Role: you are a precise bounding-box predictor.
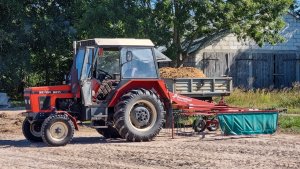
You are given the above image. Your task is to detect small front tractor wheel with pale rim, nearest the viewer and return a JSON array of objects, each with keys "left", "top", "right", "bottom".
[{"left": 41, "top": 114, "right": 75, "bottom": 146}]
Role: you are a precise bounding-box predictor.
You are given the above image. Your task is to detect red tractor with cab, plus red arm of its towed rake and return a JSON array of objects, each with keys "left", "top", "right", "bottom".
[{"left": 22, "top": 38, "right": 278, "bottom": 146}]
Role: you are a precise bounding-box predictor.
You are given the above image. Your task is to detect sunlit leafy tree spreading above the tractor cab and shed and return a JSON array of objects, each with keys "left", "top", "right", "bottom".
[{"left": 80, "top": 0, "right": 292, "bottom": 66}]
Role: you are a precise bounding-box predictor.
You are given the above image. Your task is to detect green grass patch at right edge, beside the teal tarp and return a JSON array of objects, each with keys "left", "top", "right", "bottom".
[{"left": 278, "top": 115, "right": 300, "bottom": 134}]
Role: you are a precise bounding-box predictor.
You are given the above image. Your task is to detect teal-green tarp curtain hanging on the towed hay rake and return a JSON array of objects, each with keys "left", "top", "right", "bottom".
[{"left": 217, "top": 112, "right": 278, "bottom": 135}]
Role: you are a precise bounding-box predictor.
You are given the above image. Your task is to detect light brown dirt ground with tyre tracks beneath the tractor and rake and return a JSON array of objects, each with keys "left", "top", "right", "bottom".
[{"left": 0, "top": 111, "right": 300, "bottom": 169}]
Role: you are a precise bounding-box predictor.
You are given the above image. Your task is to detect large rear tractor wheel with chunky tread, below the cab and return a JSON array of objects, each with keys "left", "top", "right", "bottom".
[{"left": 114, "top": 89, "right": 163, "bottom": 141}]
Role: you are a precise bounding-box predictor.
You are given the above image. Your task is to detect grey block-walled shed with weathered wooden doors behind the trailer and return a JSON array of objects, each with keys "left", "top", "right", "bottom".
[{"left": 189, "top": 14, "right": 300, "bottom": 88}]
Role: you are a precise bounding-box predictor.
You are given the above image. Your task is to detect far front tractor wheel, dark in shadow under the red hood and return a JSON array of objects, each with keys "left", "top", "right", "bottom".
[{"left": 22, "top": 118, "right": 43, "bottom": 142}]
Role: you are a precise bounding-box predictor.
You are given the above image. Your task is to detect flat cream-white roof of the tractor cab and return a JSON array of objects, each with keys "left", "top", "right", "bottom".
[{"left": 76, "top": 38, "right": 154, "bottom": 47}]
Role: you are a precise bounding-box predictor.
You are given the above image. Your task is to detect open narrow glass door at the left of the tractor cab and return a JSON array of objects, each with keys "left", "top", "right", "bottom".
[{"left": 80, "top": 47, "right": 95, "bottom": 106}]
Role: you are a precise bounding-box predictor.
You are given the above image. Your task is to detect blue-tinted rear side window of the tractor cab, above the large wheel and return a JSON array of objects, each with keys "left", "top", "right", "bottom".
[{"left": 121, "top": 48, "right": 158, "bottom": 78}]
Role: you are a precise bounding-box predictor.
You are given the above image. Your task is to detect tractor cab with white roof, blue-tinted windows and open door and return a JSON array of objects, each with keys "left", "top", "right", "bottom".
[{"left": 71, "top": 39, "right": 159, "bottom": 106}]
